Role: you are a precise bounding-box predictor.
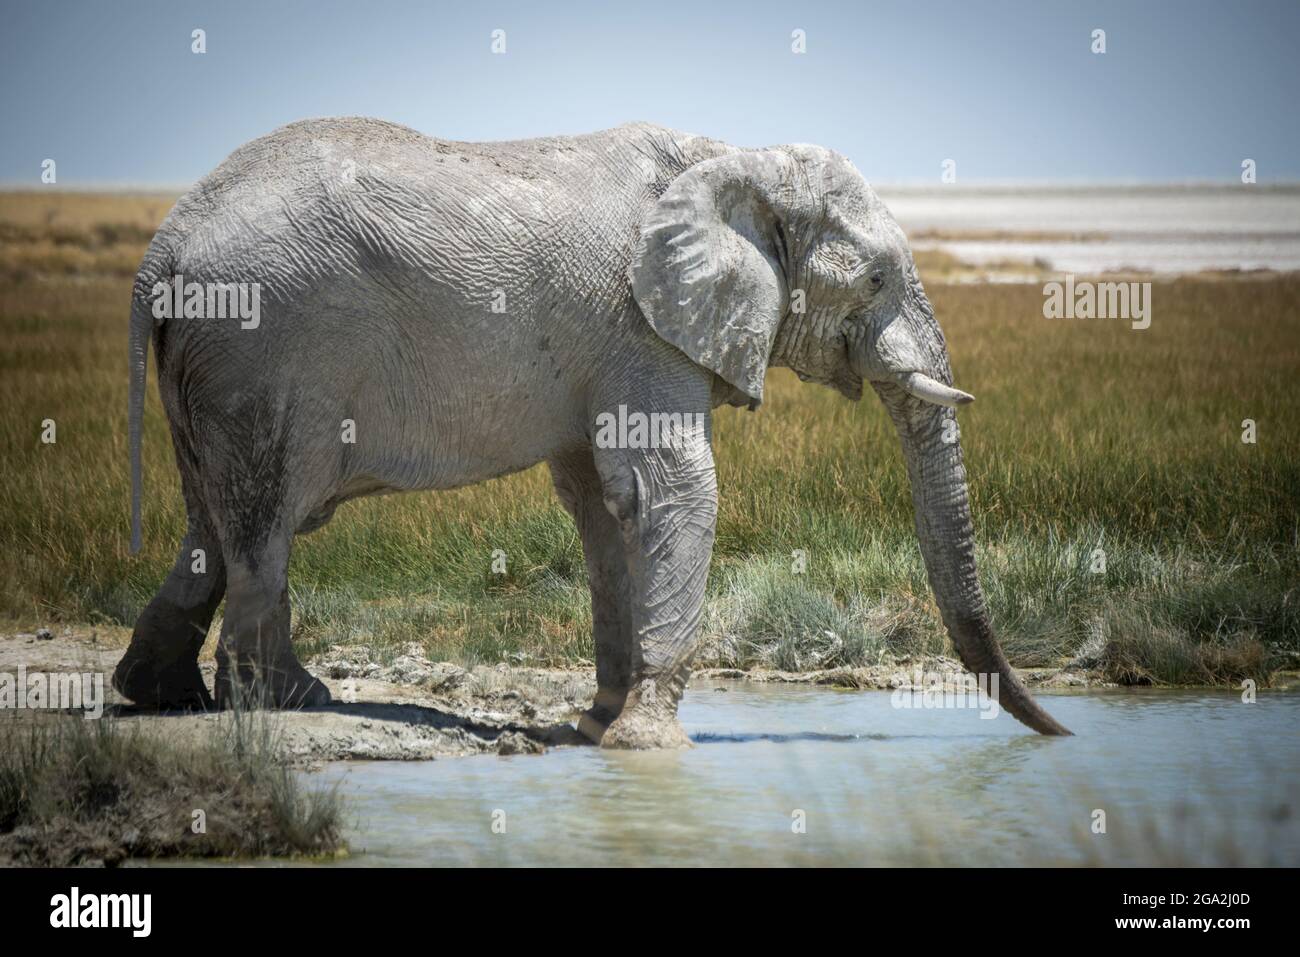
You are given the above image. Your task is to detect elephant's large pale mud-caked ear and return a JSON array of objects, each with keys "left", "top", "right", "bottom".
[{"left": 628, "top": 151, "right": 793, "bottom": 404}]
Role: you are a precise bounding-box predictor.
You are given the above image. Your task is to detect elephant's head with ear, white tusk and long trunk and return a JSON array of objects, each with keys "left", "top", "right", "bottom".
[{"left": 628, "top": 146, "right": 1069, "bottom": 735}]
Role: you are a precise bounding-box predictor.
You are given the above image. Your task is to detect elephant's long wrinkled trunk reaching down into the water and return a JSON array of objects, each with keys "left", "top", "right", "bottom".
[{"left": 878, "top": 400, "right": 1070, "bottom": 735}]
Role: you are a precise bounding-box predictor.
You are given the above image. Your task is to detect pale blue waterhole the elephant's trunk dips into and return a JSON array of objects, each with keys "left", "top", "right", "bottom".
[{"left": 308, "top": 683, "right": 1300, "bottom": 866}]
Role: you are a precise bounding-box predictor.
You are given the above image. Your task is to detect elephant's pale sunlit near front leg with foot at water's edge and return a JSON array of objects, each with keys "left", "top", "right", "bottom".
[{"left": 595, "top": 412, "right": 718, "bottom": 748}]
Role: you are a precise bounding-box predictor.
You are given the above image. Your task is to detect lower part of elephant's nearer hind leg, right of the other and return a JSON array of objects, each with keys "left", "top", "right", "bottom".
[{"left": 216, "top": 531, "right": 330, "bottom": 707}]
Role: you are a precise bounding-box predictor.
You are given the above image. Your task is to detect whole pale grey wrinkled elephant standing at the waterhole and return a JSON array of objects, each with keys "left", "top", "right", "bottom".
[{"left": 114, "top": 118, "right": 1066, "bottom": 748}]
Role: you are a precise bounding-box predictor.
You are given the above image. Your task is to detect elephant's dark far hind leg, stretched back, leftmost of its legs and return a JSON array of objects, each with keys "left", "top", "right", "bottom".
[{"left": 113, "top": 495, "right": 226, "bottom": 709}]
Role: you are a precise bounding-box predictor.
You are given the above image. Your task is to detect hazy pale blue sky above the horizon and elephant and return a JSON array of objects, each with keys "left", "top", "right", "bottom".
[{"left": 0, "top": 0, "right": 1300, "bottom": 186}]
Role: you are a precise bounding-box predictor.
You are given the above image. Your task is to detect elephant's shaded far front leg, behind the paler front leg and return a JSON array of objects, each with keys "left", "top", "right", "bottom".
[{"left": 550, "top": 449, "right": 633, "bottom": 744}]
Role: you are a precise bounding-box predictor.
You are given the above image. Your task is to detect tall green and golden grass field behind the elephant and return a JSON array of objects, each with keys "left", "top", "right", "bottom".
[{"left": 0, "top": 195, "right": 1300, "bottom": 684}]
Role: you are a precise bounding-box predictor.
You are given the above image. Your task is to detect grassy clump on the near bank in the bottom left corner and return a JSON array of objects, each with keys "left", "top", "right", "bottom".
[{"left": 0, "top": 710, "right": 345, "bottom": 867}]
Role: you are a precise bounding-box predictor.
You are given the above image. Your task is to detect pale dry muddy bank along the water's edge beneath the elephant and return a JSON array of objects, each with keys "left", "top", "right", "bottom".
[{"left": 0, "top": 629, "right": 1295, "bottom": 766}]
